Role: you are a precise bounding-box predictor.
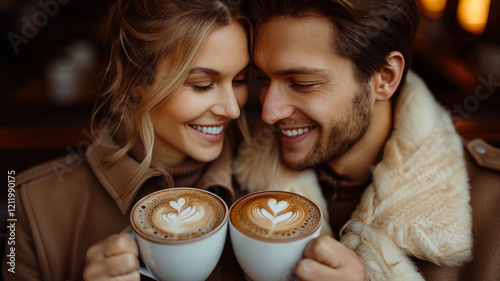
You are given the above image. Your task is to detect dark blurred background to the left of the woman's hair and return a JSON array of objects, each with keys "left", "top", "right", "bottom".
[{"left": 0, "top": 0, "right": 113, "bottom": 172}]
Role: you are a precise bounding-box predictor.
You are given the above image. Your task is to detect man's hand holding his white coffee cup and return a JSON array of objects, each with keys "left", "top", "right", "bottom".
[{"left": 296, "top": 235, "right": 366, "bottom": 281}]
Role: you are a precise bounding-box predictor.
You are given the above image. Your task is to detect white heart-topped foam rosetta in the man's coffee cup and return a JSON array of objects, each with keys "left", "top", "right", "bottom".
[{"left": 250, "top": 198, "right": 305, "bottom": 236}]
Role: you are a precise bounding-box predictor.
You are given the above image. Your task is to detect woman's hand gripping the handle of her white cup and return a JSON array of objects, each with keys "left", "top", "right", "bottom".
[{"left": 83, "top": 234, "right": 141, "bottom": 281}]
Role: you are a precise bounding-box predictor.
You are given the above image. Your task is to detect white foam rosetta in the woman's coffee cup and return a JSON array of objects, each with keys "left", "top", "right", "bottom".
[{"left": 153, "top": 197, "right": 205, "bottom": 235}]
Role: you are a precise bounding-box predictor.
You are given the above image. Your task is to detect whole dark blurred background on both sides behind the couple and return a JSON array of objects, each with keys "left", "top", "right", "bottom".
[{"left": 0, "top": 0, "right": 500, "bottom": 270}]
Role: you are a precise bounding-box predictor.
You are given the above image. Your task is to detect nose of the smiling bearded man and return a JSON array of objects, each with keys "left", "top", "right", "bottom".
[{"left": 261, "top": 83, "right": 293, "bottom": 124}]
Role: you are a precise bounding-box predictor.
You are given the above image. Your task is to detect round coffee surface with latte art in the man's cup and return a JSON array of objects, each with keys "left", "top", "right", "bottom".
[{"left": 230, "top": 191, "right": 321, "bottom": 240}]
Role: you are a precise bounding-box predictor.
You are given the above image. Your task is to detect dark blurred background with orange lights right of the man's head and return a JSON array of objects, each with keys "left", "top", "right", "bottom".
[{"left": 413, "top": 0, "right": 500, "bottom": 147}]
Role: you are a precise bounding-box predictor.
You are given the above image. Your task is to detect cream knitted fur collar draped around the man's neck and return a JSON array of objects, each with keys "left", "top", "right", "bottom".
[{"left": 235, "top": 72, "right": 472, "bottom": 280}]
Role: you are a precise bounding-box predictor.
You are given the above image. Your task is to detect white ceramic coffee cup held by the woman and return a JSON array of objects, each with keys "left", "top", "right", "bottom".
[{"left": 131, "top": 188, "right": 229, "bottom": 281}]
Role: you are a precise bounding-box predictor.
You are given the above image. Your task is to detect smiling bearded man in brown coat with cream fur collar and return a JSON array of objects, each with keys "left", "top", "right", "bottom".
[{"left": 236, "top": 0, "right": 500, "bottom": 280}]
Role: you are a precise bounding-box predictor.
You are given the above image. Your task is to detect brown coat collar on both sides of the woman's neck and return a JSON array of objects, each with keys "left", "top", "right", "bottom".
[{"left": 86, "top": 133, "right": 234, "bottom": 214}]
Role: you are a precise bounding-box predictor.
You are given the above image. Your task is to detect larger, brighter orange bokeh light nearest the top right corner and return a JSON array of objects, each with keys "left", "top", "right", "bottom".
[{"left": 457, "top": 0, "right": 491, "bottom": 35}]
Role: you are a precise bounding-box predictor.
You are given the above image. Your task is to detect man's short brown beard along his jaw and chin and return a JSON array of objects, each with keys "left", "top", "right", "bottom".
[{"left": 280, "top": 83, "right": 373, "bottom": 170}]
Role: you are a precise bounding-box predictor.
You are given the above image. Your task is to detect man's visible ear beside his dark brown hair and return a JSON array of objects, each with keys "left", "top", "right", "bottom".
[{"left": 373, "top": 51, "right": 405, "bottom": 101}]
